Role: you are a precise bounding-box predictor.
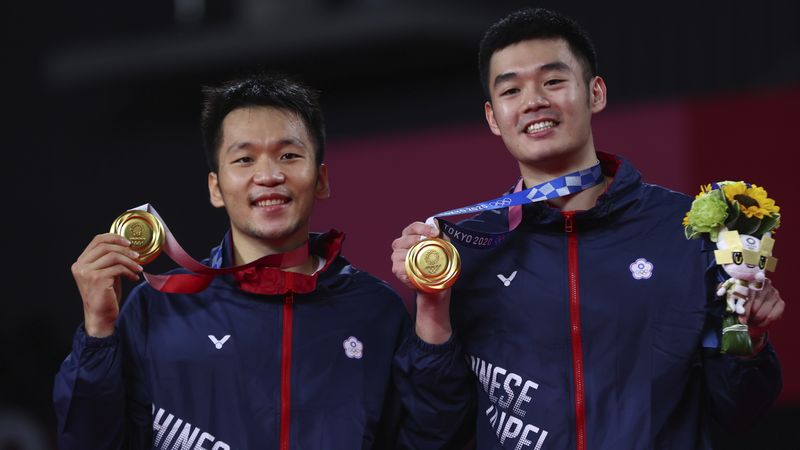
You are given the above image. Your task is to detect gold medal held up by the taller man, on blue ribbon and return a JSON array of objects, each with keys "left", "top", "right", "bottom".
[{"left": 405, "top": 238, "right": 461, "bottom": 293}]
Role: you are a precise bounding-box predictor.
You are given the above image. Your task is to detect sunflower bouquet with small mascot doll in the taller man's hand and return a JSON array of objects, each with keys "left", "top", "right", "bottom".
[{"left": 683, "top": 181, "right": 781, "bottom": 355}]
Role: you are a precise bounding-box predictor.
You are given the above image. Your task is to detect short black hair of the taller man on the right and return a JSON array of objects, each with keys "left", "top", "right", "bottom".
[{"left": 478, "top": 8, "right": 597, "bottom": 100}]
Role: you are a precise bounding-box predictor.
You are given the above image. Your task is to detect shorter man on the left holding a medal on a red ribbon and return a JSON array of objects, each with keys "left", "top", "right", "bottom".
[{"left": 54, "top": 72, "right": 469, "bottom": 450}]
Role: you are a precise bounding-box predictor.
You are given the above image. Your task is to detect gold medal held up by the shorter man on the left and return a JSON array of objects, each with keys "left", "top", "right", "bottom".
[{"left": 111, "top": 210, "right": 165, "bottom": 264}]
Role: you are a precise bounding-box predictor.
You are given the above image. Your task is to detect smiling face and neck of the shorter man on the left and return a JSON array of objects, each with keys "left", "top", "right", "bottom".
[{"left": 207, "top": 106, "right": 330, "bottom": 266}]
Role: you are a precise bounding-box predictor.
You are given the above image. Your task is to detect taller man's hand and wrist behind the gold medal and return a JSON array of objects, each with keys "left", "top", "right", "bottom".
[{"left": 392, "top": 222, "right": 453, "bottom": 344}]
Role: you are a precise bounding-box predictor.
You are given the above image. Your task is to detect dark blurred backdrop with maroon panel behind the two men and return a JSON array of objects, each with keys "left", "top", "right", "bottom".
[{"left": 0, "top": 0, "right": 800, "bottom": 450}]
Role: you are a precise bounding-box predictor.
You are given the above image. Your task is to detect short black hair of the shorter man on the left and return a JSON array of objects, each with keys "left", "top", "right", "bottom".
[{"left": 200, "top": 72, "right": 325, "bottom": 172}]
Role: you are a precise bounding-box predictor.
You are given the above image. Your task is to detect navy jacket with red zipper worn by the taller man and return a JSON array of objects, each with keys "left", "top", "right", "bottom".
[{"left": 451, "top": 154, "right": 781, "bottom": 450}]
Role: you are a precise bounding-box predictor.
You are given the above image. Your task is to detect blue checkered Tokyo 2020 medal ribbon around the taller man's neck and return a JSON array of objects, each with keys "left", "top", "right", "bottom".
[{"left": 428, "top": 162, "right": 603, "bottom": 249}]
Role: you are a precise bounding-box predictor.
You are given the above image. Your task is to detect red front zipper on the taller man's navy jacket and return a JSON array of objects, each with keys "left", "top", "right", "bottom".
[{"left": 563, "top": 211, "right": 586, "bottom": 450}]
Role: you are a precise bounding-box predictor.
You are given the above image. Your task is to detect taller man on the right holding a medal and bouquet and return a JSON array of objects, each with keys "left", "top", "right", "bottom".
[{"left": 391, "top": 9, "right": 784, "bottom": 450}]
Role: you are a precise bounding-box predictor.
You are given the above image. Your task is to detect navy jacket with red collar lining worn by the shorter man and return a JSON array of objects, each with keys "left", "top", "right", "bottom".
[{"left": 54, "top": 232, "right": 471, "bottom": 450}]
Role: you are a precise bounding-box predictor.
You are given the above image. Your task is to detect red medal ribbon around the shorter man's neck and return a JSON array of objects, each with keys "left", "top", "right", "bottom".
[{"left": 112, "top": 203, "right": 308, "bottom": 294}]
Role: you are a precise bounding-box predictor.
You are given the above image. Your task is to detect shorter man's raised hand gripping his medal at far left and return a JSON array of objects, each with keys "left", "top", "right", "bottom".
[{"left": 72, "top": 233, "right": 142, "bottom": 337}]
